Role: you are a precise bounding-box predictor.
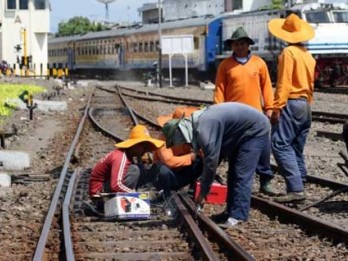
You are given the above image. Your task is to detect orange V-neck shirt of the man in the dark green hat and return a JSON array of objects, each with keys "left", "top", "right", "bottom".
[{"left": 214, "top": 55, "right": 274, "bottom": 111}]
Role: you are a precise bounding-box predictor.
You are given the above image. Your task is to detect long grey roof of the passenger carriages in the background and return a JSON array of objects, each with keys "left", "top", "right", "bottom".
[{"left": 48, "top": 16, "right": 214, "bottom": 44}]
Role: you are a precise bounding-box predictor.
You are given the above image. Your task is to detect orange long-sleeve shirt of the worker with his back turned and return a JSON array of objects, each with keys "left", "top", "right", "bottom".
[{"left": 274, "top": 45, "right": 316, "bottom": 111}]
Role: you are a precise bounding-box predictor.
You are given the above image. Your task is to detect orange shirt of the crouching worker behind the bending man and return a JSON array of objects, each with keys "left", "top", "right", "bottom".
[{"left": 154, "top": 134, "right": 192, "bottom": 169}]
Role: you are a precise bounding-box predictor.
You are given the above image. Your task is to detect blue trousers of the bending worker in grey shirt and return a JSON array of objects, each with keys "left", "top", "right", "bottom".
[{"left": 226, "top": 133, "right": 270, "bottom": 220}]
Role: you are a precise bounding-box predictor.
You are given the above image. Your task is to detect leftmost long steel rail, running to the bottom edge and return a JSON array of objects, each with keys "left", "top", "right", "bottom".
[{"left": 33, "top": 93, "right": 93, "bottom": 261}]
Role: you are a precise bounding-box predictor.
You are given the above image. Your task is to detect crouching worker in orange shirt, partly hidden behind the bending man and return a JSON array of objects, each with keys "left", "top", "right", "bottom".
[{"left": 154, "top": 107, "right": 203, "bottom": 199}]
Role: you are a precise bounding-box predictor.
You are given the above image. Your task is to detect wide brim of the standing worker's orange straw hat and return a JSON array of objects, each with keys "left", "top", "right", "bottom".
[{"left": 268, "top": 18, "right": 314, "bottom": 43}]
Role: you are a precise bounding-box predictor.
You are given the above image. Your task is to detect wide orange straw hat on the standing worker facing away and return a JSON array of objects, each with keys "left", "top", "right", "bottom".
[{"left": 268, "top": 14, "right": 314, "bottom": 43}]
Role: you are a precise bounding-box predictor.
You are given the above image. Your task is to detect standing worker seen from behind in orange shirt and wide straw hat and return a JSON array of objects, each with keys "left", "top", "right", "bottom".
[{"left": 268, "top": 14, "right": 316, "bottom": 202}]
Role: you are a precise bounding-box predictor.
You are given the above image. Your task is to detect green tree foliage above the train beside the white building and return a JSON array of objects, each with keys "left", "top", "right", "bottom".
[{"left": 56, "top": 16, "right": 109, "bottom": 36}]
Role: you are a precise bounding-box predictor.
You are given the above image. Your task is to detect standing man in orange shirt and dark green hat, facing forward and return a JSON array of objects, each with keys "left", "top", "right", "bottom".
[{"left": 214, "top": 27, "right": 276, "bottom": 196}]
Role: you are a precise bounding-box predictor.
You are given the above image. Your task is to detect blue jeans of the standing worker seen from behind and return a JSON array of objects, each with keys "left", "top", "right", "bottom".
[{"left": 271, "top": 98, "right": 312, "bottom": 192}]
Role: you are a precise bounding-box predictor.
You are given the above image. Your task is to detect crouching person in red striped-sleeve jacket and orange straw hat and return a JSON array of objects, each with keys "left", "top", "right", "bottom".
[{"left": 89, "top": 125, "right": 164, "bottom": 198}]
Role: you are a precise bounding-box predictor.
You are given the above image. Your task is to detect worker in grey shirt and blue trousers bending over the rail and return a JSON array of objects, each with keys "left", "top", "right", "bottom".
[{"left": 162, "top": 102, "right": 270, "bottom": 227}]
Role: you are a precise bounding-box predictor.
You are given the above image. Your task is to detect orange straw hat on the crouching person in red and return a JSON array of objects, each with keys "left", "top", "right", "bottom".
[{"left": 115, "top": 125, "right": 164, "bottom": 150}]
